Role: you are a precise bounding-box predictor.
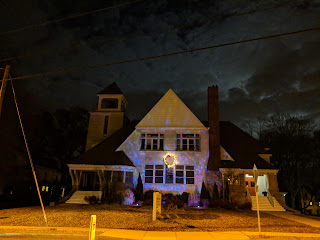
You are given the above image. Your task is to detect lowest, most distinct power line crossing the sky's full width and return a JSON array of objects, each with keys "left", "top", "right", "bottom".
[{"left": 0, "top": 27, "right": 320, "bottom": 82}]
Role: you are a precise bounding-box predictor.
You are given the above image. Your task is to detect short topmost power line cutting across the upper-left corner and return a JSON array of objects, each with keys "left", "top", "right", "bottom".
[{"left": 0, "top": 0, "right": 143, "bottom": 37}]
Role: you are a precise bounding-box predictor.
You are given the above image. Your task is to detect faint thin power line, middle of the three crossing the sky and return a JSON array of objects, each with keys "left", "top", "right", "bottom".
[{"left": 0, "top": 0, "right": 312, "bottom": 62}]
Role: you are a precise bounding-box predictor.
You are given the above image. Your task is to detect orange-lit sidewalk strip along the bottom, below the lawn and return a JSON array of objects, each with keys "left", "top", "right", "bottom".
[{"left": 0, "top": 226, "right": 320, "bottom": 240}]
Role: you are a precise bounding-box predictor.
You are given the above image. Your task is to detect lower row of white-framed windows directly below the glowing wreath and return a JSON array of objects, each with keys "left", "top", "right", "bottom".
[{"left": 144, "top": 165, "right": 194, "bottom": 184}]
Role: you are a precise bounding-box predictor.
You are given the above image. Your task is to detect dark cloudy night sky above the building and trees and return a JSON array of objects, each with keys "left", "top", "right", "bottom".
[{"left": 0, "top": 0, "right": 320, "bottom": 125}]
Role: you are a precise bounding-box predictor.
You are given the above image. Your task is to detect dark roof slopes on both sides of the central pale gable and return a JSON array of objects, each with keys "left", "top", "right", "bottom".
[{"left": 72, "top": 118, "right": 275, "bottom": 169}]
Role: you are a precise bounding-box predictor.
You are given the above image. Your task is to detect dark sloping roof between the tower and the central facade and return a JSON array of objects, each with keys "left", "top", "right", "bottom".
[{"left": 71, "top": 124, "right": 134, "bottom": 166}]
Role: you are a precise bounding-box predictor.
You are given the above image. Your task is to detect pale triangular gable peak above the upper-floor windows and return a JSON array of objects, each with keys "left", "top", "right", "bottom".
[{"left": 136, "top": 89, "right": 205, "bottom": 128}]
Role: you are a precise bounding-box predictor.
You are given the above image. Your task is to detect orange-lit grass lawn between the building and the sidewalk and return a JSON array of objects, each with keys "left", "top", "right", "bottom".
[{"left": 0, "top": 204, "right": 320, "bottom": 233}]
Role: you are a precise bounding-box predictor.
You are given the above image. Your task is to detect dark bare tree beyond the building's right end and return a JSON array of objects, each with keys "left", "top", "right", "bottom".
[{"left": 260, "top": 114, "right": 314, "bottom": 208}]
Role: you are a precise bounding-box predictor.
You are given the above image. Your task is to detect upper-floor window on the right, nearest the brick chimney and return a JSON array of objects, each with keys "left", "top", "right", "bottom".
[{"left": 177, "top": 133, "right": 200, "bottom": 151}]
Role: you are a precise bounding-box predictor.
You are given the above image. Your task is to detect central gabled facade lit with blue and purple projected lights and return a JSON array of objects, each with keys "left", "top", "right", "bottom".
[{"left": 117, "top": 89, "right": 209, "bottom": 194}]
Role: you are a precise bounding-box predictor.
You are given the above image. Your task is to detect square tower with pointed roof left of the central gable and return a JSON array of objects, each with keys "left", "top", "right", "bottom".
[{"left": 86, "top": 82, "right": 127, "bottom": 151}]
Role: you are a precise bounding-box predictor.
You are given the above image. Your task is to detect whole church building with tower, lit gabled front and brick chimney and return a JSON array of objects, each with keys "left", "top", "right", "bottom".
[{"left": 68, "top": 83, "right": 283, "bottom": 210}]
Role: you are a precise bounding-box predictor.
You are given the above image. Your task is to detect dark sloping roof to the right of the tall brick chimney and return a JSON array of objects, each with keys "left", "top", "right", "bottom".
[{"left": 220, "top": 121, "right": 275, "bottom": 169}]
